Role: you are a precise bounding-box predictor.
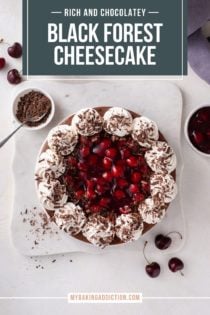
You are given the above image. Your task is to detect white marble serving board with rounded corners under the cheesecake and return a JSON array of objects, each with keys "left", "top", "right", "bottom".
[{"left": 11, "top": 81, "right": 185, "bottom": 256}]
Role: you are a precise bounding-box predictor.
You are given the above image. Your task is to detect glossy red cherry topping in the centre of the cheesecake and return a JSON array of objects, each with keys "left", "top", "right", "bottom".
[{"left": 60, "top": 130, "right": 152, "bottom": 216}]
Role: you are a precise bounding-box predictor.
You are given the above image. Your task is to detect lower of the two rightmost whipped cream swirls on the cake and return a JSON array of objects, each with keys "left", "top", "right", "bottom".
[{"left": 150, "top": 173, "right": 177, "bottom": 203}]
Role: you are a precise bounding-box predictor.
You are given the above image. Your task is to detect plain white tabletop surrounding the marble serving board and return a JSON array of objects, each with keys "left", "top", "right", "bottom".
[{"left": 0, "top": 0, "right": 210, "bottom": 315}]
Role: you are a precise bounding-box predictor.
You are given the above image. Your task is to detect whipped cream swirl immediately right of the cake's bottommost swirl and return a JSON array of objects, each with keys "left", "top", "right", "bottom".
[{"left": 115, "top": 213, "right": 144, "bottom": 243}]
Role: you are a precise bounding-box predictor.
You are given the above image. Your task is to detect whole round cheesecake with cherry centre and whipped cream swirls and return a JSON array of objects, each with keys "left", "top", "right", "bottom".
[{"left": 35, "top": 107, "right": 177, "bottom": 248}]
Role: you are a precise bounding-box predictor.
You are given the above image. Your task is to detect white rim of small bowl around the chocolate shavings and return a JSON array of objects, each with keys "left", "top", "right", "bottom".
[{"left": 12, "top": 88, "right": 55, "bottom": 130}]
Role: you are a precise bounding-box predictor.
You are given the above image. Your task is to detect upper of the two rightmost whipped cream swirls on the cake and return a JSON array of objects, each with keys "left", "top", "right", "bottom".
[{"left": 145, "top": 141, "right": 177, "bottom": 173}]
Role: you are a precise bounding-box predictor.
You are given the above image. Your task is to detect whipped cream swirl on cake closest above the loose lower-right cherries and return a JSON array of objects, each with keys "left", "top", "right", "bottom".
[{"left": 138, "top": 197, "right": 166, "bottom": 224}]
